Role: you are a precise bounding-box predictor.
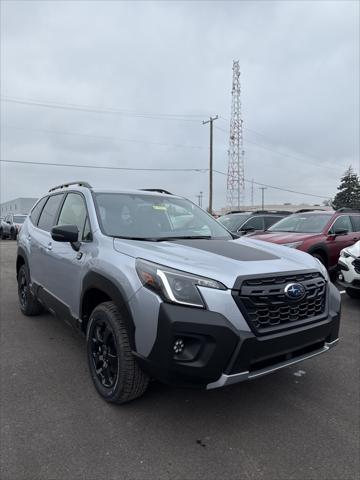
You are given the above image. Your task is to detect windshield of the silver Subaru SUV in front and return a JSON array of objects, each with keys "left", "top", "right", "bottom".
[{"left": 95, "top": 193, "right": 231, "bottom": 241}]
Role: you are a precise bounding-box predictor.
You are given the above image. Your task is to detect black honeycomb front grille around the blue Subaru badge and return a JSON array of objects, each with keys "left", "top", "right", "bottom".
[{"left": 233, "top": 272, "right": 326, "bottom": 335}]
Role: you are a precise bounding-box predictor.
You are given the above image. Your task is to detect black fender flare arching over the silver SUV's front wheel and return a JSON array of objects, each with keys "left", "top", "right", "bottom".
[{"left": 79, "top": 271, "right": 136, "bottom": 350}]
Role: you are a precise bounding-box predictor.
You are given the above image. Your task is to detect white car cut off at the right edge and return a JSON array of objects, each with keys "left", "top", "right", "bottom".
[{"left": 338, "top": 241, "right": 360, "bottom": 298}]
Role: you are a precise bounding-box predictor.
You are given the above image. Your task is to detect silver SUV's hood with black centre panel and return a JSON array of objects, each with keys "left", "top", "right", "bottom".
[{"left": 114, "top": 237, "right": 319, "bottom": 288}]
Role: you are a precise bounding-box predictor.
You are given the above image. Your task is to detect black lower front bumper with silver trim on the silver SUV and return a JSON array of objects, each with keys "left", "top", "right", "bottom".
[{"left": 134, "top": 303, "right": 340, "bottom": 389}]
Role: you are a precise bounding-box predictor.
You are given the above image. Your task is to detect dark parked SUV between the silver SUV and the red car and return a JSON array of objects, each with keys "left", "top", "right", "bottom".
[{"left": 218, "top": 210, "right": 291, "bottom": 235}]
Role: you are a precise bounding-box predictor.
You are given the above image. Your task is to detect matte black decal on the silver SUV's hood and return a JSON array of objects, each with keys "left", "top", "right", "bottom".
[{"left": 172, "top": 240, "right": 279, "bottom": 262}]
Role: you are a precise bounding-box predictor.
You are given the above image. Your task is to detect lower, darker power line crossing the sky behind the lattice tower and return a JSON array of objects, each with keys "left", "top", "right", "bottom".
[{"left": 0, "top": 159, "right": 331, "bottom": 200}]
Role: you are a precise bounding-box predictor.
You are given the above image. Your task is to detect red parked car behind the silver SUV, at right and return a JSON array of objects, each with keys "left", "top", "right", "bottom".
[{"left": 249, "top": 208, "right": 360, "bottom": 272}]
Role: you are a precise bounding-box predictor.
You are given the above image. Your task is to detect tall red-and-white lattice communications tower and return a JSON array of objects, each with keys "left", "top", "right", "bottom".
[{"left": 226, "top": 60, "right": 245, "bottom": 209}]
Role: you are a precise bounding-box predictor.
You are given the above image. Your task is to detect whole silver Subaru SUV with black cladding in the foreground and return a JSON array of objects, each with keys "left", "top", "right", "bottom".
[{"left": 16, "top": 182, "right": 340, "bottom": 403}]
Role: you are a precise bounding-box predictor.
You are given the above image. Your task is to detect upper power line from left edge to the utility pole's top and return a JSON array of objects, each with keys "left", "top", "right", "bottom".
[{"left": 0, "top": 96, "right": 204, "bottom": 123}]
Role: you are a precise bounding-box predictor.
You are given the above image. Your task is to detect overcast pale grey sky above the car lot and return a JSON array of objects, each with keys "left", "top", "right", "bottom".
[{"left": 0, "top": 0, "right": 359, "bottom": 208}]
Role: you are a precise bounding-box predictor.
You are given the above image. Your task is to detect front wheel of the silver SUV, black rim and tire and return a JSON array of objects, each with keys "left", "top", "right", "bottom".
[{"left": 86, "top": 302, "right": 149, "bottom": 404}]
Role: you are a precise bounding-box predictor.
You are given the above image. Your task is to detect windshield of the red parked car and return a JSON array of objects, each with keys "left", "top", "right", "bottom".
[{"left": 268, "top": 213, "right": 331, "bottom": 233}]
